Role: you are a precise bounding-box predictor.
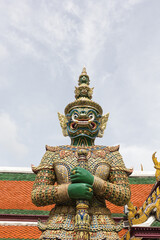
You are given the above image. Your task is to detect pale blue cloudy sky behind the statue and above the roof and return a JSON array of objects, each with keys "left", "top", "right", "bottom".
[{"left": 0, "top": 0, "right": 160, "bottom": 171}]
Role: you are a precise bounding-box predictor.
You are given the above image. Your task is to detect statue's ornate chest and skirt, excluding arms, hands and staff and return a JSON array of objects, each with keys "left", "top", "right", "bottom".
[{"left": 39, "top": 146, "right": 122, "bottom": 239}]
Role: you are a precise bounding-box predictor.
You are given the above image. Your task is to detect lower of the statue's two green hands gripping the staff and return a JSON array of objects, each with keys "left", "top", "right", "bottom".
[{"left": 68, "top": 183, "right": 93, "bottom": 200}]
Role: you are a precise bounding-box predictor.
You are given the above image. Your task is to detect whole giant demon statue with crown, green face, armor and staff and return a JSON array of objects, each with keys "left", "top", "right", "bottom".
[{"left": 32, "top": 68, "right": 130, "bottom": 240}]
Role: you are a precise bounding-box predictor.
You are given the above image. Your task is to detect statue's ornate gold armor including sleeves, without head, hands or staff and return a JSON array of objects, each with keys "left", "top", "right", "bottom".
[{"left": 32, "top": 143, "right": 130, "bottom": 240}]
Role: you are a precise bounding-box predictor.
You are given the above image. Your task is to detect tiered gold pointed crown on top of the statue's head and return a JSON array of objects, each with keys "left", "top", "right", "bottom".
[{"left": 64, "top": 67, "right": 103, "bottom": 115}]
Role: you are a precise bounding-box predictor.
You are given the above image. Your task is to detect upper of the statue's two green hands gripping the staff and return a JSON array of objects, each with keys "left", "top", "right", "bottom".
[{"left": 71, "top": 167, "right": 94, "bottom": 185}]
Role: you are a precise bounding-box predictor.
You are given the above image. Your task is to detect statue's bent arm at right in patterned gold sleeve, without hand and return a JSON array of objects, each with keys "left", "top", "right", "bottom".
[{"left": 93, "top": 154, "right": 131, "bottom": 206}]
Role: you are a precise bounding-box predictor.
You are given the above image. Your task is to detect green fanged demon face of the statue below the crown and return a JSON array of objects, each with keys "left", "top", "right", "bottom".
[{"left": 66, "top": 107, "right": 101, "bottom": 139}]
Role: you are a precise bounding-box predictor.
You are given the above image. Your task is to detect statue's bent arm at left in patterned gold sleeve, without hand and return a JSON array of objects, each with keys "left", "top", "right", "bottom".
[{"left": 31, "top": 153, "right": 69, "bottom": 206}]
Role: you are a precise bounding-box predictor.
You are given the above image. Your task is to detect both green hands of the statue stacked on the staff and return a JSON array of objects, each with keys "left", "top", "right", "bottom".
[{"left": 68, "top": 167, "right": 94, "bottom": 200}]
